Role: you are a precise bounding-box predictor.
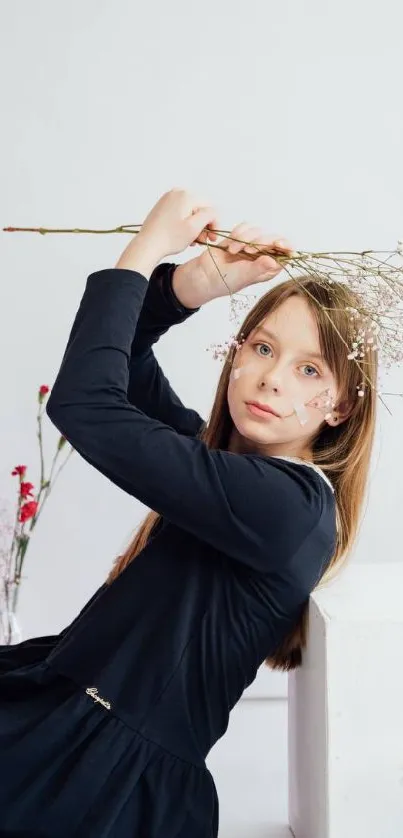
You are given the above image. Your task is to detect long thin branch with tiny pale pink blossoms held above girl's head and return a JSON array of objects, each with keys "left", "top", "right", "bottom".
[{"left": 3, "top": 224, "right": 403, "bottom": 412}]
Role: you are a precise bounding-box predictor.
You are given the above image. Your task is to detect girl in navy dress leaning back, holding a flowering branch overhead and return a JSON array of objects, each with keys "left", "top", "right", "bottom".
[{"left": 0, "top": 190, "right": 376, "bottom": 838}]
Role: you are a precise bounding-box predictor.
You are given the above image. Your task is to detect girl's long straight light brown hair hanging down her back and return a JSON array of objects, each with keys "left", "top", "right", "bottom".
[{"left": 106, "top": 274, "right": 378, "bottom": 671}]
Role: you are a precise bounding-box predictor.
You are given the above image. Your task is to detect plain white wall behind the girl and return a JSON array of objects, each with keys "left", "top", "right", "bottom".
[{"left": 0, "top": 0, "right": 403, "bottom": 832}]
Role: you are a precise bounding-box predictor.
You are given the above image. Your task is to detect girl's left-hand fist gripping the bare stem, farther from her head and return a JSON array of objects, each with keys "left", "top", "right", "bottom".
[{"left": 136, "top": 188, "right": 218, "bottom": 261}]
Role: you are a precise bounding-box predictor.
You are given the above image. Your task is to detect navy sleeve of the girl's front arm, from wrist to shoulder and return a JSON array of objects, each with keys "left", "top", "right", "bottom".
[{"left": 46, "top": 269, "right": 334, "bottom": 571}]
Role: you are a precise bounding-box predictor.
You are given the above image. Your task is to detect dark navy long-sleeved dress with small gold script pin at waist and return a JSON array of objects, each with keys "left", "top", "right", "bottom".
[{"left": 0, "top": 263, "right": 336, "bottom": 838}]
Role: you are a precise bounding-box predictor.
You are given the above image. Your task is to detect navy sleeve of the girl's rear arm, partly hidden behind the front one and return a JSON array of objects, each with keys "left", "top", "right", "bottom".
[{"left": 127, "top": 262, "right": 204, "bottom": 436}]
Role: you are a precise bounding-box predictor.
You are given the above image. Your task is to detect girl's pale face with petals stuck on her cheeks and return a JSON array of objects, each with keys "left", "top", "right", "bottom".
[{"left": 227, "top": 296, "right": 342, "bottom": 458}]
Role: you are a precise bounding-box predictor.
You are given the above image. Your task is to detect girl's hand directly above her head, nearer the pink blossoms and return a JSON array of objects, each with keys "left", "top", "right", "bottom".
[{"left": 193, "top": 222, "right": 293, "bottom": 299}]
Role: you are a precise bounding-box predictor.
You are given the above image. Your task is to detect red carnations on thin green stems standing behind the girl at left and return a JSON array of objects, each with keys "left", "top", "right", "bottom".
[{"left": 0, "top": 384, "right": 74, "bottom": 645}]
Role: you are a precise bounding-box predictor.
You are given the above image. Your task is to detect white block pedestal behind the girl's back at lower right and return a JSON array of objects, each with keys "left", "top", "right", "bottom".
[{"left": 288, "top": 560, "right": 403, "bottom": 838}]
